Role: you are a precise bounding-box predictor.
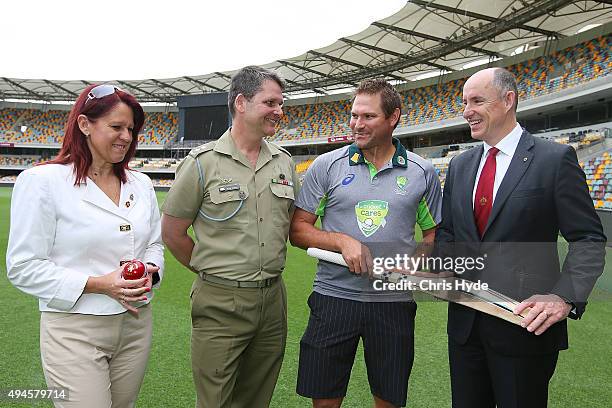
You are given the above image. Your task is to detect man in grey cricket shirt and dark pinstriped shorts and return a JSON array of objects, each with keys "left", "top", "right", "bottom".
[{"left": 290, "top": 79, "right": 441, "bottom": 407}]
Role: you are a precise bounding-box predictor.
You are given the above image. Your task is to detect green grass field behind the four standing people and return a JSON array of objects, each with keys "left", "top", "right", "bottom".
[{"left": 0, "top": 188, "right": 612, "bottom": 408}]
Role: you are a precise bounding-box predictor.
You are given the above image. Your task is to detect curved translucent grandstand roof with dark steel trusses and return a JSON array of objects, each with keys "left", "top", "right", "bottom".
[{"left": 0, "top": 0, "right": 612, "bottom": 102}]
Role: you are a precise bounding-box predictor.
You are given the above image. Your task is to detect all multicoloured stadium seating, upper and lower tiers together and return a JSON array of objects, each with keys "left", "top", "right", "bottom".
[{"left": 0, "top": 35, "right": 612, "bottom": 210}]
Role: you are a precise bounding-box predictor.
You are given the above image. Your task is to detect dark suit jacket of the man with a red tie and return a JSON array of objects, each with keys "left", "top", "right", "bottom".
[{"left": 436, "top": 131, "right": 606, "bottom": 355}]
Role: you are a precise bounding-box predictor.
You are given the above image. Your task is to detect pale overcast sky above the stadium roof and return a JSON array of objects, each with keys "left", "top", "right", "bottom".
[{"left": 0, "top": 0, "right": 406, "bottom": 81}]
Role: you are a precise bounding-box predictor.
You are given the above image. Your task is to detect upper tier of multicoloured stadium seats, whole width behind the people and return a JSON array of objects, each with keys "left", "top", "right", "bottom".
[{"left": 0, "top": 35, "right": 612, "bottom": 146}]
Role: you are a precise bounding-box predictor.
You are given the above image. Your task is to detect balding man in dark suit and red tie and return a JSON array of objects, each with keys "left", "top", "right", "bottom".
[{"left": 436, "top": 68, "right": 606, "bottom": 408}]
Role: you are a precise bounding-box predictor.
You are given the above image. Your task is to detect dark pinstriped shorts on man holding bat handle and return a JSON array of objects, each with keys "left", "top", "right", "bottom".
[{"left": 297, "top": 292, "right": 416, "bottom": 407}]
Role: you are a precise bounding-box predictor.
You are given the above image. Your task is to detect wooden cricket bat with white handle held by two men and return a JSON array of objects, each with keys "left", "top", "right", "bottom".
[{"left": 306, "top": 248, "right": 529, "bottom": 325}]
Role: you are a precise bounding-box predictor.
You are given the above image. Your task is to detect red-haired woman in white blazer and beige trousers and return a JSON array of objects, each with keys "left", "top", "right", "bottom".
[{"left": 6, "top": 85, "right": 164, "bottom": 408}]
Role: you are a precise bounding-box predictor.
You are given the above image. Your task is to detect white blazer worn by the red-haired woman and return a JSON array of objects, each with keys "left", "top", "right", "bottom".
[{"left": 6, "top": 164, "right": 164, "bottom": 315}]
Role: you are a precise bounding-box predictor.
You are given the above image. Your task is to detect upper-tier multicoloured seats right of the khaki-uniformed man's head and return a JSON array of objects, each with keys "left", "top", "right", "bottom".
[{"left": 273, "top": 35, "right": 612, "bottom": 141}]
